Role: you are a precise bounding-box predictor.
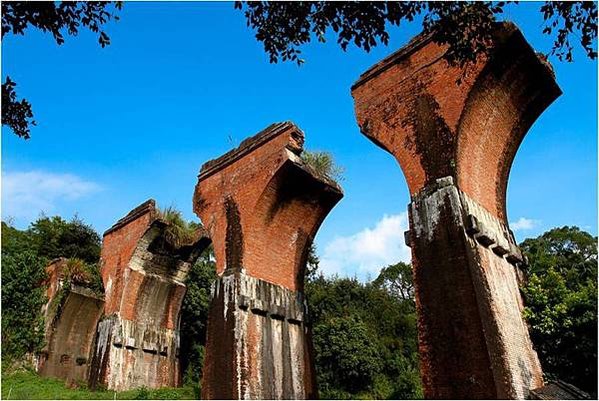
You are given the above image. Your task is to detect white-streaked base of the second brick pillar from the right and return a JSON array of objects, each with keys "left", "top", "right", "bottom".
[{"left": 202, "top": 272, "right": 316, "bottom": 399}]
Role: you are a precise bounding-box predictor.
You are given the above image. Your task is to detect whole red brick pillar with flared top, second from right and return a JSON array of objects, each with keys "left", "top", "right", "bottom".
[{"left": 194, "top": 123, "right": 342, "bottom": 399}]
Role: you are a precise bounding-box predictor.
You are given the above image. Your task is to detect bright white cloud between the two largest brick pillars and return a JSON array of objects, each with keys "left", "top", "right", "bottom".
[{"left": 320, "top": 213, "right": 411, "bottom": 279}]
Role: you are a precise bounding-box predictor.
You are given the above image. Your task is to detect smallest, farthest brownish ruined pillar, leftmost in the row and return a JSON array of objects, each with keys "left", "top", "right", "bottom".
[{"left": 37, "top": 258, "right": 104, "bottom": 385}]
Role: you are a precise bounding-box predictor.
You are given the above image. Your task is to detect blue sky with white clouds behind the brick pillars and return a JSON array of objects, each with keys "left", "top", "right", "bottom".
[{"left": 2, "top": 2, "right": 597, "bottom": 278}]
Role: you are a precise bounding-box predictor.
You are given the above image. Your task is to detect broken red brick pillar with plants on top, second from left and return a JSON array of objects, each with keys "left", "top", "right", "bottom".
[{"left": 89, "top": 200, "right": 210, "bottom": 391}]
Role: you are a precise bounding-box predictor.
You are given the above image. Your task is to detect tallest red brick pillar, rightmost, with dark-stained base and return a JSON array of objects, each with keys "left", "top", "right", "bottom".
[{"left": 352, "top": 24, "right": 561, "bottom": 399}]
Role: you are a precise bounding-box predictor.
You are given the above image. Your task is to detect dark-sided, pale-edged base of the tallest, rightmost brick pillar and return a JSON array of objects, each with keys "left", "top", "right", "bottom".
[{"left": 408, "top": 177, "right": 543, "bottom": 399}]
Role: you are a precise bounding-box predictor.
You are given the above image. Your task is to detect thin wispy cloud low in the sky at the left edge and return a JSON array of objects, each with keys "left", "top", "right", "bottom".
[{"left": 2, "top": 170, "right": 100, "bottom": 221}]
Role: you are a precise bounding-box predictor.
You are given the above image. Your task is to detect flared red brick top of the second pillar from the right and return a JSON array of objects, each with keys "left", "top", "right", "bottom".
[{"left": 193, "top": 122, "right": 343, "bottom": 290}]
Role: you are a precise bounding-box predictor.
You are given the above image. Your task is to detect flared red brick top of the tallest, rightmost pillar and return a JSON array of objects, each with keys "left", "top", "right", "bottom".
[{"left": 352, "top": 23, "right": 561, "bottom": 221}]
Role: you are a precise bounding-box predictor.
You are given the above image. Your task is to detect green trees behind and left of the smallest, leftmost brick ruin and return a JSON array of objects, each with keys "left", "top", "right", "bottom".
[{"left": 2, "top": 216, "right": 102, "bottom": 361}]
